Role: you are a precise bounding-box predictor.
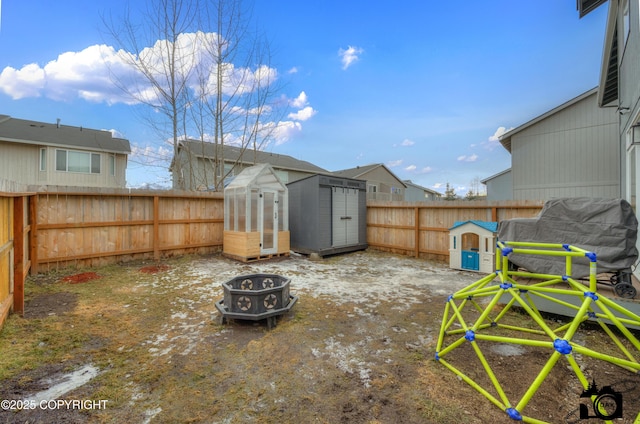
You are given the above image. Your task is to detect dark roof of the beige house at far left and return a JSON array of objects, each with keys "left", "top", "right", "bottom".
[{"left": 0, "top": 115, "right": 131, "bottom": 154}]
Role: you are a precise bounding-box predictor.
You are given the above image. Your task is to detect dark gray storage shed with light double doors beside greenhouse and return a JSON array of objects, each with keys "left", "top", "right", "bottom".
[{"left": 287, "top": 175, "right": 367, "bottom": 256}]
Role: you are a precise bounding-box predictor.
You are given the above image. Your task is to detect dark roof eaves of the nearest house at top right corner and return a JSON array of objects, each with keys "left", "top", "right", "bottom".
[{"left": 577, "top": 0, "right": 618, "bottom": 107}]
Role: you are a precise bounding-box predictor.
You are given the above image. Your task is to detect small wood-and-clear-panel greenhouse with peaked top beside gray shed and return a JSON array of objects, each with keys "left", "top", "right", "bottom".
[{"left": 222, "top": 164, "right": 289, "bottom": 262}]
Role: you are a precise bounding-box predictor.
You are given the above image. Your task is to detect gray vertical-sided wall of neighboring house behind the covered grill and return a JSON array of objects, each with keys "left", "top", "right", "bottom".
[{"left": 503, "top": 90, "right": 621, "bottom": 200}]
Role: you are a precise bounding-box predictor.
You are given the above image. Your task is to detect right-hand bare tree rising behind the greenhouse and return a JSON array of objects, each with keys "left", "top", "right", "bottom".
[{"left": 192, "top": 0, "right": 282, "bottom": 190}]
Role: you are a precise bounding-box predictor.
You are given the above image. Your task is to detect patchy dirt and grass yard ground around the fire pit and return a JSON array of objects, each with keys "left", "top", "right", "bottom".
[{"left": 0, "top": 251, "right": 640, "bottom": 423}]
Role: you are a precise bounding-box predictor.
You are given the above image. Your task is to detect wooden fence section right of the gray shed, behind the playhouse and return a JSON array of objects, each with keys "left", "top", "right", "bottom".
[{"left": 367, "top": 200, "right": 543, "bottom": 261}]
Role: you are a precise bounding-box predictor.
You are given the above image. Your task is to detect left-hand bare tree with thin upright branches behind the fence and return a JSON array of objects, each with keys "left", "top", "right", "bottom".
[{"left": 103, "top": 0, "right": 198, "bottom": 188}]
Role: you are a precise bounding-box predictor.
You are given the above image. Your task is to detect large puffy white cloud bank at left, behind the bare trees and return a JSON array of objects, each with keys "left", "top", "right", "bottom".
[{"left": 0, "top": 32, "right": 278, "bottom": 104}]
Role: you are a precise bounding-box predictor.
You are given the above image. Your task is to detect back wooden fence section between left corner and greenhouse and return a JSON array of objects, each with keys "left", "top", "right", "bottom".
[{"left": 31, "top": 190, "right": 224, "bottom": 272}]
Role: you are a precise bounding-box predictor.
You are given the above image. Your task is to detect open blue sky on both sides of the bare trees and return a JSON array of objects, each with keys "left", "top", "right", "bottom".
[{"left": 0, "top": 0, "right": 606, "bottom": 195}]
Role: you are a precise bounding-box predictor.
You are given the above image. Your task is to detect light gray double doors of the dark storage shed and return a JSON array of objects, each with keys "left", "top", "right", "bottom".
[{"left": 332, "top": 187, "right": 358, "bottom": 247}]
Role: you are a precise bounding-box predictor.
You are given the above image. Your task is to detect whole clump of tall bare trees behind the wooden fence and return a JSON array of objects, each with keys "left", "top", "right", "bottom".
[{"left": 103, "top": 0, "right": 281, "bottom": 190}]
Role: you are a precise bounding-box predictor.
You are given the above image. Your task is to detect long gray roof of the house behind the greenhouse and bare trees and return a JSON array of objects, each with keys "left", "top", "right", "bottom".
[{"left": 180, "top": 140, "right": 330, "bottom": 174}]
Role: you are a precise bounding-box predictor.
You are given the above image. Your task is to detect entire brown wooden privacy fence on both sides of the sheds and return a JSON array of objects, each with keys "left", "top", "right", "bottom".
[{"left": 0, "top": 190, "right": 542, "bottom": 326}]
